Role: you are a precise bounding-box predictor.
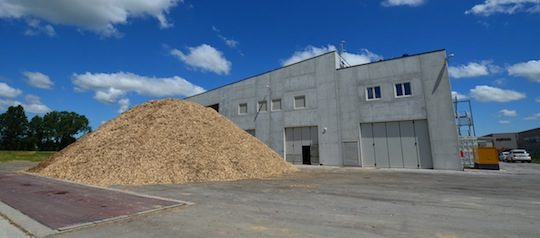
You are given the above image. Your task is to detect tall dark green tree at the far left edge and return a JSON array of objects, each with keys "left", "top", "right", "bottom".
[{"left": 0, "top": 105, "right": 28, "bottom": 150}]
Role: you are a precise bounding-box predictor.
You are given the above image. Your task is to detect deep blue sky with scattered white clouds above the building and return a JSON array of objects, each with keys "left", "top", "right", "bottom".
[{"left": 0, "top": 0, "right": 540, "bottom": 135}]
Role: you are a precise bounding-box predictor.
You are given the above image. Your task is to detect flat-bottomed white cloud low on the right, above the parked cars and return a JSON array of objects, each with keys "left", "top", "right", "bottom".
[{"left": 470, "top": 85, "right": 527, "bottom": 102}]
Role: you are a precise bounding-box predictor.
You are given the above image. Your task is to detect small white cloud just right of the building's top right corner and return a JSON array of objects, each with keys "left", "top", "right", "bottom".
[{"left": 448, "top": 60, "right": 501, "bottom": 79}]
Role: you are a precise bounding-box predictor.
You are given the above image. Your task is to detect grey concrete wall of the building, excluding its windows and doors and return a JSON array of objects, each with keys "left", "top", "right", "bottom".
[{"left": 187, "top": 51, "right": 462, "bottom": 170}]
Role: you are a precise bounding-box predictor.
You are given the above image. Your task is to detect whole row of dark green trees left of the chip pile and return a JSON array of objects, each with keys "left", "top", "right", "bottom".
[{"left": 0, "top": 105, "right": 92, "bottom": 151}]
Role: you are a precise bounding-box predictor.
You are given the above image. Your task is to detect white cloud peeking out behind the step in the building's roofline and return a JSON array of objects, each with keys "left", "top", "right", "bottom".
[{"left": 281, "top": 45, "right": 382, "bottom": 66}]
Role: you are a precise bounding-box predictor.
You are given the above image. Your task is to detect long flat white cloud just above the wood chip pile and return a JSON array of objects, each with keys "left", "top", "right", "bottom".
[{"left": 73, "top": 72, "right": 205, "bottom": 103}]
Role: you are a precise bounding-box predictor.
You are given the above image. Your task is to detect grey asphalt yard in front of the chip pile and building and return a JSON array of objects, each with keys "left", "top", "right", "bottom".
[{"left": 0, "top": 162, "right": 540, "bottom": 237}]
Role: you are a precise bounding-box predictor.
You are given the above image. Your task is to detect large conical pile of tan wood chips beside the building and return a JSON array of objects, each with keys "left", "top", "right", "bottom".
[{"left": 29, "top": 99, "right": 296, "bottom": 186}]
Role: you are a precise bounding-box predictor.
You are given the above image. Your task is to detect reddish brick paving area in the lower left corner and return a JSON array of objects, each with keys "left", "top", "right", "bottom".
[{"left": 0, "top": 173, "right": 178, "bottom": 229}]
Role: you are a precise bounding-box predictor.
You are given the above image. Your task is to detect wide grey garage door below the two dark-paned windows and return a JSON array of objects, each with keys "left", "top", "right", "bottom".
[{"left": 360, "top": 120, "right": 433, "bottom": 168}]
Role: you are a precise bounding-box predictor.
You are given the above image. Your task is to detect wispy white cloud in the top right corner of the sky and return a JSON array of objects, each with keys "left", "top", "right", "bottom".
[{"left": 465, "top": 0, "right": 540, "bottom": 16}]
